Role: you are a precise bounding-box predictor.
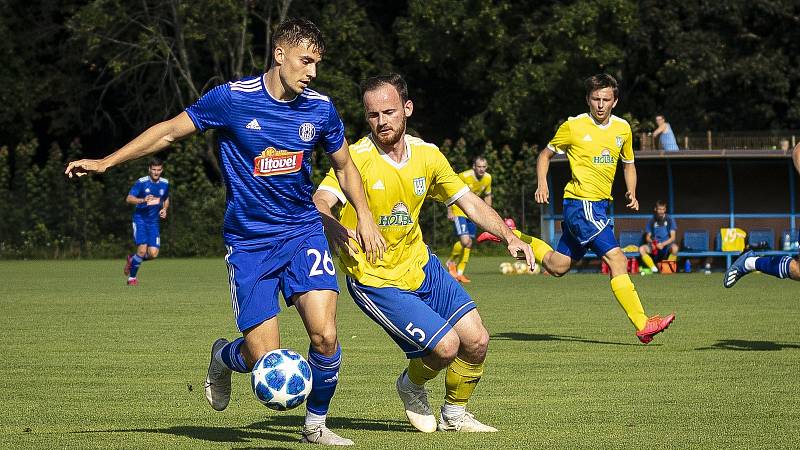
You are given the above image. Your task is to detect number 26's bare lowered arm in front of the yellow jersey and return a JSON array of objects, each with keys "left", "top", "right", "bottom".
[{"left": 328, "top": 141, "right": 386, "bottom": 263}]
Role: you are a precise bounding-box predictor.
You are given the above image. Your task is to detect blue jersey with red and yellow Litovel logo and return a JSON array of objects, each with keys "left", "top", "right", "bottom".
[{"left": 186, "top": 76, "right": 344, "bottom": 247}]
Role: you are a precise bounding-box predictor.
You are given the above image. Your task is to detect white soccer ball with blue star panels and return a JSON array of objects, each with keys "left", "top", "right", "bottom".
[{"left": 250, "top": 348, "right": 311, "bottom": 411}]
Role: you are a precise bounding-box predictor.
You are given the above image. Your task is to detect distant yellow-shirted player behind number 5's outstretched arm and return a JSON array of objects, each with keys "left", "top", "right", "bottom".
[{"left": 446, "top": 156, "right": 492, "bottom": 283}]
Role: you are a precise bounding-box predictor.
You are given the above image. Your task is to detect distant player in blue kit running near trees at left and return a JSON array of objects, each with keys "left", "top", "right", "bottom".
[{"left": 124, "top": 158, "right": 169, "bottom": 286}]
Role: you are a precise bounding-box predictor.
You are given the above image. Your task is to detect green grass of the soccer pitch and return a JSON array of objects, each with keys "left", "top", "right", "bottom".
[{"left": 0, "top": 257, "right": 800, "bottom": 449}]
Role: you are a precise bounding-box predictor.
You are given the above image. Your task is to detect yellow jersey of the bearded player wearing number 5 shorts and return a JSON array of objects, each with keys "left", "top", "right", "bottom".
[{"left": 318, "top": 135, "right": 469, "bottom": 290}]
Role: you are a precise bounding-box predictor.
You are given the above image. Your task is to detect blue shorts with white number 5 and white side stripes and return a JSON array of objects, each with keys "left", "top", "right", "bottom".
[{"left": 347, "top": 250, "right": 475, "bottom": 359}]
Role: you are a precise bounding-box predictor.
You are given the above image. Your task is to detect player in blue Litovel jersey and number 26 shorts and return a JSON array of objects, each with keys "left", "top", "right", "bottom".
[{"left": 66, "top": 19, "right": 386, "bottom": 445}]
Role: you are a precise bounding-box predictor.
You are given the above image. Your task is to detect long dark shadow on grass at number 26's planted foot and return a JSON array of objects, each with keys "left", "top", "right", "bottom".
[{"left": 75, "top": 415, "right": 415, "bottom": 448}]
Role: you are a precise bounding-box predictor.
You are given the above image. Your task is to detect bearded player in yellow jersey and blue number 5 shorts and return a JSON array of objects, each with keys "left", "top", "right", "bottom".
[{"left": 314, "top": 74, "right": 533, "bottom": 432}]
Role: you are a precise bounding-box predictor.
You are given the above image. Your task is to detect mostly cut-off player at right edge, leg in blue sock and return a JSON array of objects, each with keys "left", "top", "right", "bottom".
[{"left": 722, "top": 144, "right": 800, "bottom": 288}]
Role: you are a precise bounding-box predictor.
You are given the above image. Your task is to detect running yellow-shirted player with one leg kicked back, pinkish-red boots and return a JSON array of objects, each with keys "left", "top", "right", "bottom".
[{"left": 515, "top": 74, "right": 675, "bottom": 344}]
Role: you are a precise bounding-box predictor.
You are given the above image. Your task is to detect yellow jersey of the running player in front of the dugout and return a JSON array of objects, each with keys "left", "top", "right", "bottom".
[{"left": 547, "top": 113, "right": 633, "bottom": 201}]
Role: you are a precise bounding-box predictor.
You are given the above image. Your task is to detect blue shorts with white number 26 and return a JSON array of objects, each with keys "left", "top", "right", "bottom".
[{"left": 225, "top": 227, "right": 339, "bottom": 332}]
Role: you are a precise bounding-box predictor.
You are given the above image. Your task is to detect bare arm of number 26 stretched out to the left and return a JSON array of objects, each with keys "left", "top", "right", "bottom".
[{"left": 64, "top": 112, "right": 197, "bottom": 178}]
